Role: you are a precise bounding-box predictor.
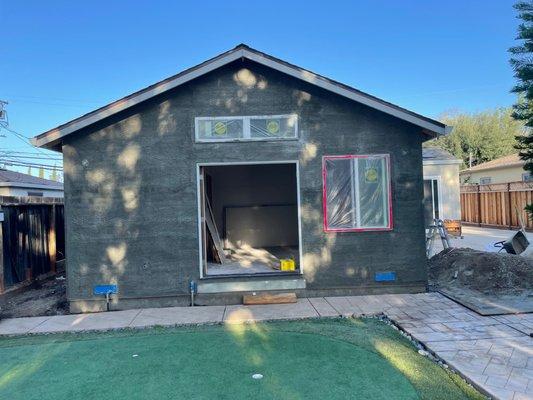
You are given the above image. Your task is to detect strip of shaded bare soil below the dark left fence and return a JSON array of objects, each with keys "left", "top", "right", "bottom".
[{"left": 0, "top": 277, "right": 68, "bottom": 319}]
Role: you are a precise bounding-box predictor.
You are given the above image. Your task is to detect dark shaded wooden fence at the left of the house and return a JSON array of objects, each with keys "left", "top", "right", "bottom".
[{"left": 0, "top": 196, "right": 65, "bottom": 293}]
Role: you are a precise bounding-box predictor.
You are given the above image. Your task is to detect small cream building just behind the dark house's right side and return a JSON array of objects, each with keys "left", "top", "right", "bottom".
[{"left": 422, "top": 147, "right": 462, "bottom": 226}]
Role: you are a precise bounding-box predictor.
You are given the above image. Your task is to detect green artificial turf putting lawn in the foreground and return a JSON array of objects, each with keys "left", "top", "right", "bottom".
[{"left": 0, "top": 319, "right": 483, "bottom": 400}]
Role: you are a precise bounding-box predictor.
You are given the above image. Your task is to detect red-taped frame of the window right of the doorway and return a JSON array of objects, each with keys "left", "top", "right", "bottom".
[{"left": 322, "top": 153, "right": 393, "bottom": 233}]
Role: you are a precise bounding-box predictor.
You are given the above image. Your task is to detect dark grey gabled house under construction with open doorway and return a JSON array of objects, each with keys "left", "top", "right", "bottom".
[{"left": 33, "top": 45, "right": 448, "bottom": 312}]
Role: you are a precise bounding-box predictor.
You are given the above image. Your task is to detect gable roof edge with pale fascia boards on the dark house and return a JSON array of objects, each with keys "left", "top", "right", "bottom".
[{"left": 32, "top": 44, "right": 451, "bottom": 149}]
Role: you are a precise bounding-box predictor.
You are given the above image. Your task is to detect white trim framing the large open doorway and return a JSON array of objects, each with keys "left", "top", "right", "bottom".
[{"left": 196, "top": 160, "right": 304, "bottom": 279}]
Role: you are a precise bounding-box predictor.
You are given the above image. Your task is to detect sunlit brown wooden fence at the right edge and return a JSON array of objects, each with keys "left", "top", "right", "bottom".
[{"left": 461, "top": 182, "right": 533, "bottom": 229}]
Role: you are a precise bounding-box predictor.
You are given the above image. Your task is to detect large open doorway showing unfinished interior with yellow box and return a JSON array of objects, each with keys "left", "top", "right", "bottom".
[{"left": 200, "top": 163, "right": 300, "bottom": 276}]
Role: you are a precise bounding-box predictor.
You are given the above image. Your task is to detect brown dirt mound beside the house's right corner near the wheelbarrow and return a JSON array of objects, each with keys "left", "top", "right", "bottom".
[{"left": 429, "top": 248, "right": 533, "bottom": 294}]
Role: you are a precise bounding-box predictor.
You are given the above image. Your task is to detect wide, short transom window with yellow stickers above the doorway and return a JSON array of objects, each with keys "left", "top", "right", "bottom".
[{"left": 194, "top": 114, "right": 298, "bottom": 142}]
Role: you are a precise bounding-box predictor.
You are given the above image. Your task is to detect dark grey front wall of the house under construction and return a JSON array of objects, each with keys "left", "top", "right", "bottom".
[{"left": 63, "top": 61, "right": 426, "bottom": 310}]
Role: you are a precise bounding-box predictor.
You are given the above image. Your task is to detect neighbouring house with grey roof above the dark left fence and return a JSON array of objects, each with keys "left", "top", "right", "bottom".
[{"left": 0, "top": 168, "right": 63, "bottom": 197}]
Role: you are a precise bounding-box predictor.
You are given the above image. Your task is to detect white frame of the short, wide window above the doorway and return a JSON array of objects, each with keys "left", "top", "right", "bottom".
[{"left": 194, "top": 113, "right": 299, "bottom": 143}]
